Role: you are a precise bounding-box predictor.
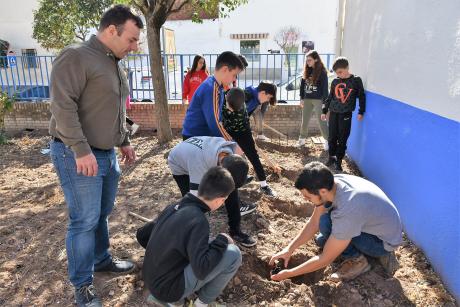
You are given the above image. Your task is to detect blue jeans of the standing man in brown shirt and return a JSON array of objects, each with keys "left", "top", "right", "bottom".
[{"left": 50, "top": 141, "right": 121, "bottom": 288}]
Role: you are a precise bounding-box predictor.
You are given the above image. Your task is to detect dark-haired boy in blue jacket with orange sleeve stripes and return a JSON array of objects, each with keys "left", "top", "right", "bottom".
[{"left": 182, "top": 51, "right": 255, "bottom": 214}]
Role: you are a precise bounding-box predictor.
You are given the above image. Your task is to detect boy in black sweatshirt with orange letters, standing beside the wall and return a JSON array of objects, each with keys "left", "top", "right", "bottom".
[{"left": 321, "top": 57, "right": 366, "bottom": 171}]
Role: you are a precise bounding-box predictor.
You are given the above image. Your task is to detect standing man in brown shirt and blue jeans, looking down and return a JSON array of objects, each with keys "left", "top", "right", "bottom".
[{"left": 50, "top": 5, "right": 143, "bottom": 306}]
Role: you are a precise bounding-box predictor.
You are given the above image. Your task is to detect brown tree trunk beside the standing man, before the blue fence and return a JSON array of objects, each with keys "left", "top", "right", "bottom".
[{"left": 146, "top": 17, "right": 172, "bottom": 144}]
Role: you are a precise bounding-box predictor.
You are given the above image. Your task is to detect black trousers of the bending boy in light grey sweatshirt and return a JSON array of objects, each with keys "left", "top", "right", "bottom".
[{"left": 173, "top": 175, "right": 241, "bottom": 232}]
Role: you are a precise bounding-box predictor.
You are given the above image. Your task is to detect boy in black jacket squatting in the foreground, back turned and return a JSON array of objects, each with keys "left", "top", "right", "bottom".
[{"left": 137, "top": 166, "right": 241, "bottom": 307}]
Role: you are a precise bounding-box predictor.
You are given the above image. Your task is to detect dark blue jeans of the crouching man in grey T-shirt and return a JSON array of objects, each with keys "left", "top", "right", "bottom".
[{"left": 315, "top": 212, "right": 389, "bottom": 259}]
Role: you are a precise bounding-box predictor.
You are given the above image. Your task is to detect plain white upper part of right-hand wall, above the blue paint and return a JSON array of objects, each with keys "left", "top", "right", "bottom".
[{"left": 342, "top": 0, "right": 460, "bottom": 121}]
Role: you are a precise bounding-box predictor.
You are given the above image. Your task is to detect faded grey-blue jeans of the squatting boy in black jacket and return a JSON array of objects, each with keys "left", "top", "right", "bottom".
[{"left": 181, "top": 244, "right": 241, "bottom": 304}]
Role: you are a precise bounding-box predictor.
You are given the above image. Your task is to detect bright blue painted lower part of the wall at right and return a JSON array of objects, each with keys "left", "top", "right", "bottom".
[{"left": 348, "top": 92, "right": 460, "bottom": 301}]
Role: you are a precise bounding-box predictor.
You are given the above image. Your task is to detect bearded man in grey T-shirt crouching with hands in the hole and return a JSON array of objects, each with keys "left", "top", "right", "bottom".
[{"left": 270, "top": 162, "right": 402, "bottom": 281}]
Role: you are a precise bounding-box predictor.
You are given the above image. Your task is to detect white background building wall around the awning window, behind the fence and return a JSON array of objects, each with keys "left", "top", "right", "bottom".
[{"left": 165, "top": 0, "right": 338, "bottom": 53}]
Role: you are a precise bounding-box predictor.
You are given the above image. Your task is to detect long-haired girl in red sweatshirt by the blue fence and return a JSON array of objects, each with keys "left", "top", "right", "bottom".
[{"left": 182, "top": 55, "right": 209, "bottom": 104}]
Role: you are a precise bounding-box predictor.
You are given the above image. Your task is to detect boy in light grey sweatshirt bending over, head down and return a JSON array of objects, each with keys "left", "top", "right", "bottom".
[{"left": 168, "top": 136, "right": 256, "bottom": 247}]
